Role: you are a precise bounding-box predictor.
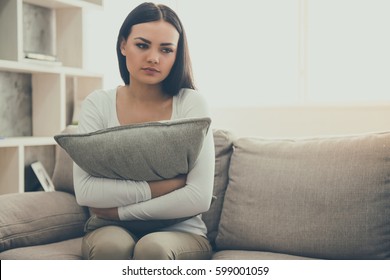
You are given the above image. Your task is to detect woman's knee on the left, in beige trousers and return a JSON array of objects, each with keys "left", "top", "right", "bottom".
[{"left": 82, "top": 226, "right": 135, "bottom": 260}]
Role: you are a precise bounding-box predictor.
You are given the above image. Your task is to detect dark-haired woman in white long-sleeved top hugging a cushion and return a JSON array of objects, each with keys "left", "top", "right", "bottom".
[{"left": 74, "top": 3, "right": 215, "bottom": 259}]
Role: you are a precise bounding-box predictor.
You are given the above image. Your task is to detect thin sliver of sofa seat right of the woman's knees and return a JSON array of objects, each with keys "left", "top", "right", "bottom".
[{"left": 212, "top": 250, "right": 311, "bottom": 260}]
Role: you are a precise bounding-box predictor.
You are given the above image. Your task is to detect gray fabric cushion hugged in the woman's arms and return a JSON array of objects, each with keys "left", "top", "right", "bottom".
[{"left": 55, "top": 118, "right": 211, "bottom": 181}]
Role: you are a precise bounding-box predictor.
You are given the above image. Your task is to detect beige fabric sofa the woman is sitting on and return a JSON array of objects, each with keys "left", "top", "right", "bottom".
[{"left": 0, "top": 130, "right": 390, "bottom": 260}]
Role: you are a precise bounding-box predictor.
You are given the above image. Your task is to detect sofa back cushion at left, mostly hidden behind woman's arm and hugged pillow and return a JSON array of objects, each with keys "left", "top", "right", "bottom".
[{"left": 52, "top": 125, "right": 77, "bottom": 194}]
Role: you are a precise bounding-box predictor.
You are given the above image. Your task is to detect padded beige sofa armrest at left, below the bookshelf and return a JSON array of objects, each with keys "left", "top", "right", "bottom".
[{"left": 0, "top": 191, "right": 89, "bottom": 252}]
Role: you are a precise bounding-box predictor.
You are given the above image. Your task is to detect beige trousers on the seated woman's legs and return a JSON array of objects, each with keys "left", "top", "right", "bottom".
[{"left": 82, "top": 226, "right": 212, "bottom": 260}]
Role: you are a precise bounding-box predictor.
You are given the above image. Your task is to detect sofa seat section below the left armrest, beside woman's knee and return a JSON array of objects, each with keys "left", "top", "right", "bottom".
[{"left": 0, "top": 237, "right": 82, "bottom": 260}]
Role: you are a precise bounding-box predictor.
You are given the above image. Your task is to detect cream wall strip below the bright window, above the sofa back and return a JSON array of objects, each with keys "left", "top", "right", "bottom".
[{"left": 212, "top": 105, "right": 390, "bottom": 138}]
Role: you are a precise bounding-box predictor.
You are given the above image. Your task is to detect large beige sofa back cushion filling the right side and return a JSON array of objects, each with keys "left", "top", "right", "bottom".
[{"left": 216, "top": 133, "right": 390, "bottom": 259}]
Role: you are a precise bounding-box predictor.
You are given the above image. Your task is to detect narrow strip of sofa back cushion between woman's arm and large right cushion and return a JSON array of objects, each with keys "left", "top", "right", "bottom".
[{"left": 202, "top": 129, "right": 234, "bottom": 245}]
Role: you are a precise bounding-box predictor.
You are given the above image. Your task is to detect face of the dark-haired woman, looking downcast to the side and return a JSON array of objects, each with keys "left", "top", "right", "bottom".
[{"left": 121, "top": 20, "right": 180, "bottom": 85}]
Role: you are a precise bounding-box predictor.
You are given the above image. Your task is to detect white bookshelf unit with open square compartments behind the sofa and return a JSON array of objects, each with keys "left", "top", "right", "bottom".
[{"left": 0, "top": 0, "right": 103, "bottom": 195}]
